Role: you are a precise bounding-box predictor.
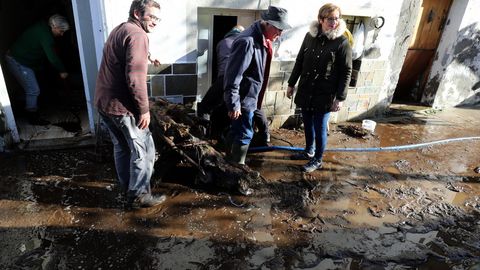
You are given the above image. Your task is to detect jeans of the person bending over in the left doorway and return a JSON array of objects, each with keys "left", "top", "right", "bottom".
[{"left": 5, "top": 55, "right": 40, "bottom": 112}]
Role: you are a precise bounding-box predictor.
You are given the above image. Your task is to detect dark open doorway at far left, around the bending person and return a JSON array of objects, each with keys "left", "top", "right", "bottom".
[{"left": 0, "top": 0, "right": 91, "bottom": 150}]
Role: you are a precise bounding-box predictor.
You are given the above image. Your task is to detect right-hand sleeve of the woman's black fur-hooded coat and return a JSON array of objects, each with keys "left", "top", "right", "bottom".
[{"left": 336, "top": 39, "right": 352, "bottom": 101}]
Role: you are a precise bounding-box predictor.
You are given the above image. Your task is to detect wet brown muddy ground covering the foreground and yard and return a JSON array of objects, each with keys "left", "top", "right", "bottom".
[{"left": 0, "top": 108, "right": 480, "bottom": 269}]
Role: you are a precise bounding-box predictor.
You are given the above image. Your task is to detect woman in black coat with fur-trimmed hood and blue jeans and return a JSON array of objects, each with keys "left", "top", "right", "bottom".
[{"left": 287, "top": 4, "right": 352, "bottom": 172}]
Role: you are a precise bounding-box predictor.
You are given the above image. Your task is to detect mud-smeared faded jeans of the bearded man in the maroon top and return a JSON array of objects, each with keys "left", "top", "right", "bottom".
[{"left": 99, "top": 112, "right": 155, "bottom": 197}]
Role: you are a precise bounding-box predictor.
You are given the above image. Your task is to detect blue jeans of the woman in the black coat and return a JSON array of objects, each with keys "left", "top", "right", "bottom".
[{"left": 302, "top": 109, "right": 330, "bottom": 161}]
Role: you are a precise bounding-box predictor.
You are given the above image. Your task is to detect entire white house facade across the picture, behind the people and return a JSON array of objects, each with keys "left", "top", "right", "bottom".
[{"left": 0, "top": 0, "right": 480, "bottom": 150}]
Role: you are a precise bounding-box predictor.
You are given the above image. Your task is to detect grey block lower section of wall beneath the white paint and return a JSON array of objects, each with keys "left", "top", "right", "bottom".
[{"left": 147, "top": 59, "right": 387, "bottom": 128}]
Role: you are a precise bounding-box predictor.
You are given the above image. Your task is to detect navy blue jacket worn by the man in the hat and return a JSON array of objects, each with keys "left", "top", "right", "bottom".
[{"left": 223, "top": 21, "right": 267, "bottom": 112}]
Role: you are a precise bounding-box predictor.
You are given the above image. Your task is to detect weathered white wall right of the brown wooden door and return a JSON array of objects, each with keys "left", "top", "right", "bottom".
[{"left": 422, "top": 0, "right": 480, "bottom": 108}]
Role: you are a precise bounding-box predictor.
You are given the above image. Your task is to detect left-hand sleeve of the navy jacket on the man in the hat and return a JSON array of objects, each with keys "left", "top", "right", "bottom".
[{"left": 223, "top": 38, "right": 254, "bottom": 111}]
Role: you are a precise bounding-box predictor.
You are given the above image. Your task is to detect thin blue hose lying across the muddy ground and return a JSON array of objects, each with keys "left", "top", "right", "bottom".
[{"left": 248, "top": 137, "right": 480, "bottom": 153}]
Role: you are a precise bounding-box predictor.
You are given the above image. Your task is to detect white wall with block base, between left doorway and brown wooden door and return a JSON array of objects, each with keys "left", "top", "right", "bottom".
[{"left": 96, "top": 0, "right": 420, "bottom": 126}]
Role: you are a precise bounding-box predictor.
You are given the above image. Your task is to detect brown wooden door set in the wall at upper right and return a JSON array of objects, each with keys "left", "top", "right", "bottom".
[{"left": 393, "top": 0, "right": 453, "bottom": 103}]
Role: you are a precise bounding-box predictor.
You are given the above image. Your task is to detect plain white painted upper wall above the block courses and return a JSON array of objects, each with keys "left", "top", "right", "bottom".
[{"left": 100, "top": 0, "right": 402, "bottom": 63}]
